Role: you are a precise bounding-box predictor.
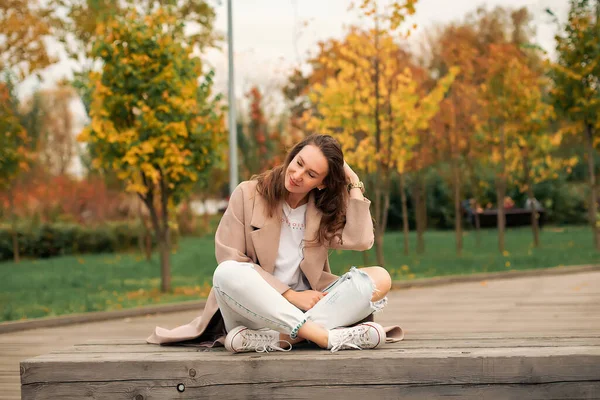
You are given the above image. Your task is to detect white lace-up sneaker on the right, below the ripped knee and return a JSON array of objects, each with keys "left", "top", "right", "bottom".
[{"left": 327, "top": 322, "right": 385, "bottom": 353}]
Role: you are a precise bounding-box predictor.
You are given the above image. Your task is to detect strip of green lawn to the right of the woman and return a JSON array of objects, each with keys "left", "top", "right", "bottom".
[{"left": 330, "top": 226, "right": 600, "bottom": 279}]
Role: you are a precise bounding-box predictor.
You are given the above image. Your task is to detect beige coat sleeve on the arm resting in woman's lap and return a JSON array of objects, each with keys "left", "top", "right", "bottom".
[{"left": 215, "top": 182, "right": 290, "bottom": 293}]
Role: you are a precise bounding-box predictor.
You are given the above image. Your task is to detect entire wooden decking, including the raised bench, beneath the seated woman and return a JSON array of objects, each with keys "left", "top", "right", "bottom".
[{"left": 8, "top": 272, "right": 600, "bottom": 400}]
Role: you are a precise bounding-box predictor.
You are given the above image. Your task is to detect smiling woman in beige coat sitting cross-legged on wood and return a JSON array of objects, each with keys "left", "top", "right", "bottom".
[{"left": 148, "top": 135, "right": 402, "bottom": 352}]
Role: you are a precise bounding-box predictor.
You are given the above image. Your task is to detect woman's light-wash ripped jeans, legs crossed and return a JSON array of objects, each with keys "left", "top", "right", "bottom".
[{"left": 213, "top": 260, "right": 387, "bottom": 339}]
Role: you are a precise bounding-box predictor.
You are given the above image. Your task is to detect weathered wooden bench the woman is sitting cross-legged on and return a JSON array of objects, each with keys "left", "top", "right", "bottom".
[{"left": 21, "top": 333, "right": 600, "bottom": 400}]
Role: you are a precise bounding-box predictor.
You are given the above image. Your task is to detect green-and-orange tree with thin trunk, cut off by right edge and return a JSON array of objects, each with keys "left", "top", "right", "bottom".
[{"left": 550, "top": 0, "right": 600, "bottom": 250}]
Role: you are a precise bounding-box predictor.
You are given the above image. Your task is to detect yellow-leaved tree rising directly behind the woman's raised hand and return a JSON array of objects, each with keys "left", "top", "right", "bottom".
[{"left": 309, "top": 23, "right": 453, "bottom": 265}]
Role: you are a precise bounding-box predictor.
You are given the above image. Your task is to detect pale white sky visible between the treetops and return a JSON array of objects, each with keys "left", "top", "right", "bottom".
[{"left": 19, "top": 0, "right": 568, "bottom": 101}]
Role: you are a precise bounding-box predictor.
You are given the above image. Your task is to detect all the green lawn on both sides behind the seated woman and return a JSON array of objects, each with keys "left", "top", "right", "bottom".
[{"left": 0, "top": 227, "right": 600, "bottom": 321}]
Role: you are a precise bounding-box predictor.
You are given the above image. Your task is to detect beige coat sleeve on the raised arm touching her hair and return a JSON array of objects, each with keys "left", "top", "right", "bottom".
[{"left": 329, "top": 198, "right": 375, "bottom": 251}]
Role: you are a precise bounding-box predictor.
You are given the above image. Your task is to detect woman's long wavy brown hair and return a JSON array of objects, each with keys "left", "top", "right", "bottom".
[{"left": 252, "top": 135, "right": 348, "bottom": 244}]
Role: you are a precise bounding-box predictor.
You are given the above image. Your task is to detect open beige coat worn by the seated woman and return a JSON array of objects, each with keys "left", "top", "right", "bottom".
[{"left": 147, "top": 181, "right": 403, "bottom": 346}]
